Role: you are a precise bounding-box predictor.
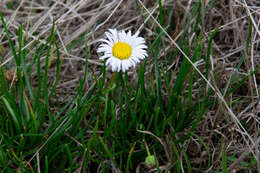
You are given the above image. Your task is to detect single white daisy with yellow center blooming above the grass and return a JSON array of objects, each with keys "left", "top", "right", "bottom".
[{"left": 97, "top": 29, "right": 147, "bottom": 72}]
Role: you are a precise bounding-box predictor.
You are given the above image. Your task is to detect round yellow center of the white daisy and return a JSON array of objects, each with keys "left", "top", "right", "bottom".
[{"left": 112, "top": 41, "right": 132, "bottom": 60}]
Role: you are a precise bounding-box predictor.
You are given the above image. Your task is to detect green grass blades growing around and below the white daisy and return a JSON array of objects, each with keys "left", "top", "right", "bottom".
[{"left": 0, "top": 0, "right": 259, "bottom": 173}]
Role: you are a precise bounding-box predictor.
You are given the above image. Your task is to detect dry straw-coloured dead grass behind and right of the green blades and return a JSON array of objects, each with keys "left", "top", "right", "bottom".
[{"left": 0, "top": 0, "right": 260, "bottom": 172}]
